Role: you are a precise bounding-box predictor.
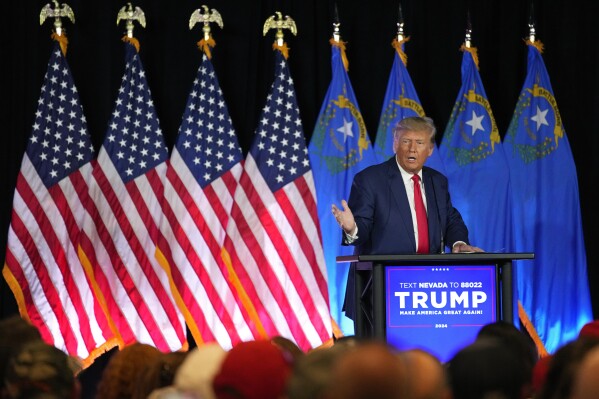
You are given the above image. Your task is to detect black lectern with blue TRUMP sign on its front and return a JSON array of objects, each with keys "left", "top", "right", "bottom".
[{"left": 337, "top": 252, "right": 534, "bottom": 361}]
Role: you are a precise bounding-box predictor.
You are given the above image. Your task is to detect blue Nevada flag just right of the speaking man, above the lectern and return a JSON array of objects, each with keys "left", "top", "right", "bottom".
[{"left": 439, "top": 46, "right": 512, "bottom": 252}]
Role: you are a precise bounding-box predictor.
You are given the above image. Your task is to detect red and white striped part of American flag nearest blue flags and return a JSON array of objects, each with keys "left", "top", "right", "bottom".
[{"left": 225, "top": 154, "right": 331, "bottom": 350}]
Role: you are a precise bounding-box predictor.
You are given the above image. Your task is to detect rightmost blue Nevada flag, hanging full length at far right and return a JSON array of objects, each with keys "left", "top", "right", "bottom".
[{"left": 504, "top": 41, "right": 593, "bottom": 353}]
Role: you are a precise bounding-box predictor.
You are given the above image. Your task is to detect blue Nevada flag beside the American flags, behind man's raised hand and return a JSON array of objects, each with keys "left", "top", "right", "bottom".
[{"left": 308, "top": 45, "right": 376, "bottom": 335}]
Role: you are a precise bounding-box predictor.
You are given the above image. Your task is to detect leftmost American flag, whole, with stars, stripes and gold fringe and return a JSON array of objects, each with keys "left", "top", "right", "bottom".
[{"left": 3, "top": 43, "right": 117, "bottom": 364}]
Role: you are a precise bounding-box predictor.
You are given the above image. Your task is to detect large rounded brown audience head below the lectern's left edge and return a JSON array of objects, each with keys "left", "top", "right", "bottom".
[{"left": 326, "top": 341, "right": 409, "bottom": 399}]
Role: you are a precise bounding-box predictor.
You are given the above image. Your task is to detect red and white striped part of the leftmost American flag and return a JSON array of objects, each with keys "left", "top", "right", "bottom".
[{"left": 3, "top": 154, "right": 116, "bottom": 363}]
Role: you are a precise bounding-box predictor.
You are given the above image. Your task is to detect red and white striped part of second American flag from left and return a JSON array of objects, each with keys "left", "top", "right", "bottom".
[{"left": 81, "top": 152, "right": 186, "bottom": 351}]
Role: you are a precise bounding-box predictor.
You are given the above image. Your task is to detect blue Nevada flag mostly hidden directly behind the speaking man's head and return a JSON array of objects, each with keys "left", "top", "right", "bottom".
[{"left": 374, "top": 39, "right": 445, "bottom": 174}]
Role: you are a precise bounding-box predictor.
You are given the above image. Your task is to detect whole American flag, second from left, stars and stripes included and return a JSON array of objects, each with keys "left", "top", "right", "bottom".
[{"left": 81, "top": 43, "right": 186, "bottom": 351}]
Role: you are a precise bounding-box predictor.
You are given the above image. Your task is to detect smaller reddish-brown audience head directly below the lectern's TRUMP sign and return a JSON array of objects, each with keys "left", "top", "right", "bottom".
[{"left": 400, "top": 349, "right": 451, "bottom": 399}]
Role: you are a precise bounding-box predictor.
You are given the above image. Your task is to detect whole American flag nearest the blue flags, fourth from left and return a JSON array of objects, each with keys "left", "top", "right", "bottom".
[{"left": 224, "top": 51, "right": 331, "bottom": 350}]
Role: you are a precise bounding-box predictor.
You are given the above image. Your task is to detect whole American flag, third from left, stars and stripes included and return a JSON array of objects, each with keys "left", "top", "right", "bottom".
[{"left": 159, "top": 51, "right": 254, "bottom": 349}]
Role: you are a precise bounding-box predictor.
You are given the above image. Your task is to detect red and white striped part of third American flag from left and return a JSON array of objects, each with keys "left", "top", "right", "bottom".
[{"left": 159, "top": 148, "right": 255, "bottom": 349}]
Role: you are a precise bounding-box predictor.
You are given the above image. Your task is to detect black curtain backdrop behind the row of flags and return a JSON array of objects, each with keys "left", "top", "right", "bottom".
[{"left": 0, "top": 0, "right": 599, "bottom": 317}]
